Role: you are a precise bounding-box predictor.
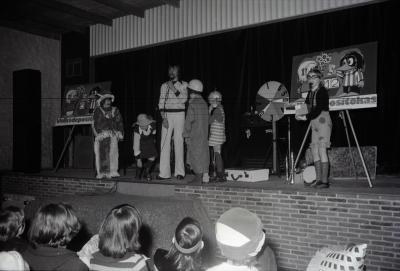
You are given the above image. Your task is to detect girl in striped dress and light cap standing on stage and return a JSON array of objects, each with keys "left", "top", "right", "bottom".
[{"left": 208, "top": 90, "right": 226, "bottom": 182}]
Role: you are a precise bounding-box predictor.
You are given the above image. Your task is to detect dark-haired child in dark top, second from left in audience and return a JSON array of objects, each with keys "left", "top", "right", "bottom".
[{"left": 22, "top": 203, "right": 88, "bottom": 271}]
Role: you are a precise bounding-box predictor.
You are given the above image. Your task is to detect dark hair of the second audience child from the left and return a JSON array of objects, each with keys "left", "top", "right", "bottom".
[{"left": 28, "top": 203, "right": 81, "bottom": 247}]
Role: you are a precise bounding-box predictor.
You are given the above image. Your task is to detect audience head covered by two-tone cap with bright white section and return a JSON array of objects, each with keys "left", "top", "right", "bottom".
[{"left": 215, "top": 207, "right": 265, "bottom": 264}]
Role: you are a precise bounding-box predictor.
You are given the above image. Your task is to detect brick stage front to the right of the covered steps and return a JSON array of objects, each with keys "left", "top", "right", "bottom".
[{"left": 175, "top": 186, "right": 400, "bottom": 271}]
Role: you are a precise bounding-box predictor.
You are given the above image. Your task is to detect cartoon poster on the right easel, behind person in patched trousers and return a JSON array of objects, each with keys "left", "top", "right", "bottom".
[{"left": 285, "top": 42, "right": 377, "bottom": 111}]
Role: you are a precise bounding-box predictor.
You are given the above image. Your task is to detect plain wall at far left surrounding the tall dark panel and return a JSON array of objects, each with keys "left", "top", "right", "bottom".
[{"left": 0, "top": 27, "right": 61, "bottom": 170}]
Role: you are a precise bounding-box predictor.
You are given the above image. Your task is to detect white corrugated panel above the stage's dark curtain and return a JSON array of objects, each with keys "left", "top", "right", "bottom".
[{"left": 90, "top": 0, "right": 382, "bottom": 56}]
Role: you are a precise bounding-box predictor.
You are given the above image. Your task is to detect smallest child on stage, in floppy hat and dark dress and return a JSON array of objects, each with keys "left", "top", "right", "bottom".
[{"left": 133, "top": 114, "right": 157, "bottom": 181}]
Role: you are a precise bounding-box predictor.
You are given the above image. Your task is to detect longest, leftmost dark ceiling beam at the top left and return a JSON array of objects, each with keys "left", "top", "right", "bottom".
[{"left": 31, "top": 0, "right": 112, "bottom": 26}]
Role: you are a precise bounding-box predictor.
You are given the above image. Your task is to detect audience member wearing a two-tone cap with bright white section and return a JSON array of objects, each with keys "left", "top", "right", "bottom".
[{"left": 207, "top": 207, "right": 277, "bottom": 271}]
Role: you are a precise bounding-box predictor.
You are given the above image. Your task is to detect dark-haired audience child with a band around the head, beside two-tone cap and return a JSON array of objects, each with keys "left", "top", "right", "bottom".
[{"left": 154, "top": 217, "right": 204, "bottom": 271}]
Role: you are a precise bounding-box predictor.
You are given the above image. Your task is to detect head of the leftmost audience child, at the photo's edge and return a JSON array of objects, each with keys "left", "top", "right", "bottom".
[{"left": 0, "top": 206, "right": 25, "bottom": 242}]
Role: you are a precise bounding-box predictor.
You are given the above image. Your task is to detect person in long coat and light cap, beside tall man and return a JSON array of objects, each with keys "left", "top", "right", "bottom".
[{"left": 183, "top": 79, "right": 210, "bottom": 183}]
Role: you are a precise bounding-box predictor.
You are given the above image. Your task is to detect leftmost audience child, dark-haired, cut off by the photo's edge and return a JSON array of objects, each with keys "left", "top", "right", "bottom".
[{"left": 0, "top": 206, "right": 28, "bottom": 252}]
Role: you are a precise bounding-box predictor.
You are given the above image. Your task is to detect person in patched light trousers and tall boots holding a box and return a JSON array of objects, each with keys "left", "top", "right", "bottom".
[{"left": 296, "top": 67, "right": 332, "bottom": 188}]
